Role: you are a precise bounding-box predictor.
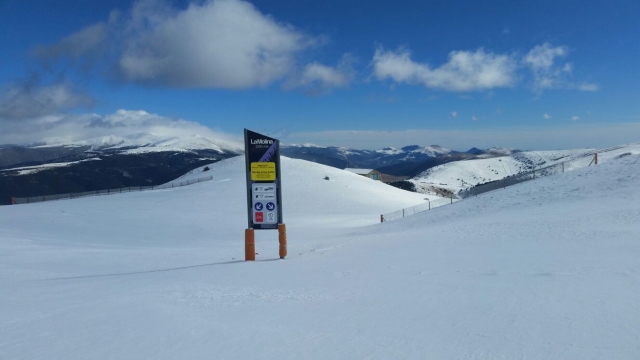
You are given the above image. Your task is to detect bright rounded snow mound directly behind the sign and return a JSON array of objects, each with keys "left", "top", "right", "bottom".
[{"left": 170, "top": 156, "right": 425, "bottom": 227}]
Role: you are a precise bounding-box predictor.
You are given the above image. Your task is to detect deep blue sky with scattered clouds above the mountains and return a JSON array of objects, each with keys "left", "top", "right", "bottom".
[{"left": 0, "top": 0, "right": 640, "bottom": 150}]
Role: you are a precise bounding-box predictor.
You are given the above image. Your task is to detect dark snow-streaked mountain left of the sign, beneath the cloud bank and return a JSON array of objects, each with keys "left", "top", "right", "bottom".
[{"left": 0, "top": 139, "right": 239, "bottom": 205}]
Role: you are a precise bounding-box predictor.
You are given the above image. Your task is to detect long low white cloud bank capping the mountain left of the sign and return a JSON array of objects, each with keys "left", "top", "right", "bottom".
[{"left": 0, "top": 110, "right": 243, "bottom": 151}]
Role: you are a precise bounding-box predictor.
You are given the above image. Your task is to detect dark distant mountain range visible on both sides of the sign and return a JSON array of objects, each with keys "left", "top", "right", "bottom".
[{"left": 0, "top": 134, "right": 517, "bottom": 205}]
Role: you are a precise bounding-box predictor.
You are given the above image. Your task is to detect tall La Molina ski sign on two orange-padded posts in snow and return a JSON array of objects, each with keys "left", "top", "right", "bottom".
[{"left": 244, "top": 129, "right": 287, "bottom": 261}]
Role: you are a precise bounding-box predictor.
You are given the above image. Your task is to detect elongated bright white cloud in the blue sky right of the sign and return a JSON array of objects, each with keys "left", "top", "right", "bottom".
[{"left": 373, "top": 48, "right": 517, "bottom": 92}]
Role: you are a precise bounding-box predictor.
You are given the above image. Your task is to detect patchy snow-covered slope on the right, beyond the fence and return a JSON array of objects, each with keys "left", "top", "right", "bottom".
[{"left": 409, "top": 144, "right": 640, "bottom": 194}]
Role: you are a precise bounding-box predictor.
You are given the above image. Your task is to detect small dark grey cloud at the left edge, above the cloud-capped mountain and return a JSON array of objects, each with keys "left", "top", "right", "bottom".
[{"left": 0, "top": 78, "right": 95, "bottom": 119}]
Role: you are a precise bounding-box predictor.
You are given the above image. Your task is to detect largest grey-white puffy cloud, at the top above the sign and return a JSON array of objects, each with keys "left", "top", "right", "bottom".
[{"left": 119, "top": 0, "right": 312, "bottom": 89}]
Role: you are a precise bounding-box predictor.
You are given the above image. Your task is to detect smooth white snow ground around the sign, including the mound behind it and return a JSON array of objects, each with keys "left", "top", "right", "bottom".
[{"left": 0, "top": 154, "right": 640, "bottom": 360}]
